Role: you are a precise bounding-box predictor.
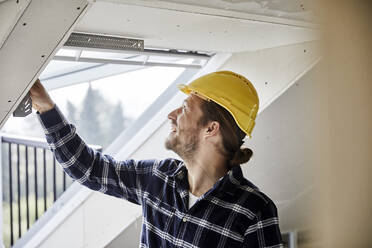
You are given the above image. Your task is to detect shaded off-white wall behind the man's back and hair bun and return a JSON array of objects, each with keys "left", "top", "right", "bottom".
[{"left": 248, "top": 66, "right": 328, "bottom": 231}]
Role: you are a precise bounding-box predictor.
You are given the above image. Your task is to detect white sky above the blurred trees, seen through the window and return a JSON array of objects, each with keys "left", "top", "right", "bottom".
[{"left": 50, "top": 67, "right": 184, "bottom": 118}]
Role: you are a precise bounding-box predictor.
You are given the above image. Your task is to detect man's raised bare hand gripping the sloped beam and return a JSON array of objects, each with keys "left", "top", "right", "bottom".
[{"left": 30, "top": 79, "right": 54, "bottom": 114}]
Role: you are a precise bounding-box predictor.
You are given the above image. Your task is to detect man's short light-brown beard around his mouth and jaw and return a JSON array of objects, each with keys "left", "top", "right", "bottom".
[{"left": 164, "top": 129, "right": 199, "bottom": 161}]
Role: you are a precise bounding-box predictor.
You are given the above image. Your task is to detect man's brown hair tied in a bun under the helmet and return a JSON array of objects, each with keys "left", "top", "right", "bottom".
[{"left": 198, "top": 101, "right": 253, "bottom": 169}]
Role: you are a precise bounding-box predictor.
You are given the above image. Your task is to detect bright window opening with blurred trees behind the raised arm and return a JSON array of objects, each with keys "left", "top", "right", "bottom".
[{"left": 1, "top": 48, "right": 209, "bottom": 149}]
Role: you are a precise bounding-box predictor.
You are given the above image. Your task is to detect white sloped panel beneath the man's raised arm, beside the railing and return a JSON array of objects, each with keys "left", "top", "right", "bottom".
[{"left": 34, "top": 192, "right": 141, "bottom": 248}]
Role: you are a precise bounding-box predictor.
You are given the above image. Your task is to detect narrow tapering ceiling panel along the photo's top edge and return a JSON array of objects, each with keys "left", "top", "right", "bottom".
[{"left": 98, "top": 0, "right": 319, "bottom": 27}]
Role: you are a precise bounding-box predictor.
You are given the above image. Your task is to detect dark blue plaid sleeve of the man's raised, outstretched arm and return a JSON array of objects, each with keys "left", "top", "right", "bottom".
[{"left": 37, "top": 105, "right": 157, "bottom": 205}]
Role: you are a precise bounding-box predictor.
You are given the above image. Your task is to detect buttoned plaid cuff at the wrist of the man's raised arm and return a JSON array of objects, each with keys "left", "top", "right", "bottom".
[{"left": 36, "top": 104, "right": 69, "bottom": 134}]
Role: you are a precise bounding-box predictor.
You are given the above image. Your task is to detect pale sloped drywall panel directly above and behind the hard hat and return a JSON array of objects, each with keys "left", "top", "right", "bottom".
[{"left": 220, "top": 41, "right": 321, "bottom": 111}]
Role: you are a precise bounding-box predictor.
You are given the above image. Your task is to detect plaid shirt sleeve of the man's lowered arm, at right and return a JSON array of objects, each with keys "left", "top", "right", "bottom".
[{"left": 244, "top": 200, "right": 284, "bottom": 248}]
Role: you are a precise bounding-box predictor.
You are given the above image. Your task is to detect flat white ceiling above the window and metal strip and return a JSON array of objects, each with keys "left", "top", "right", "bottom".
[{"left": 74, "top": 0, "right": 318, "bottom": 52}]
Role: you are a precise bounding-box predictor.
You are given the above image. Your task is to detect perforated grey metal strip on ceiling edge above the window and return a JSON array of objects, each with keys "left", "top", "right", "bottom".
[{"left": 64, "top": 33, "right": 144, "bottom": 51}]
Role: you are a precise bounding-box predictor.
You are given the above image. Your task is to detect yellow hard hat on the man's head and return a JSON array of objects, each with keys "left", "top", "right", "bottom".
[{"left": 178, "top": 71, "right": 259, "bottom": 138}]
